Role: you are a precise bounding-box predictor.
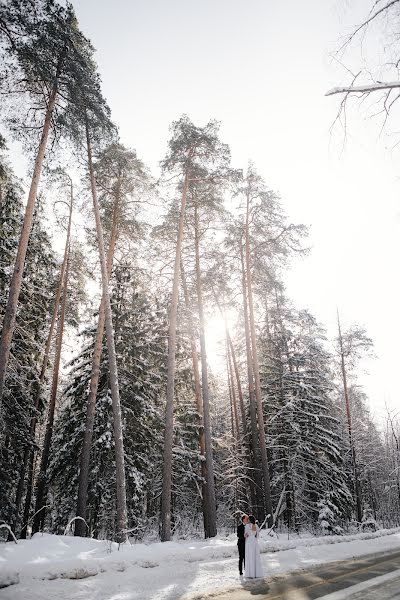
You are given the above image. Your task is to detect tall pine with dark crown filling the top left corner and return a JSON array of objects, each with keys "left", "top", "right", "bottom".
[{"left": 0, "top": 0, "right": 104, "bottom": 416}]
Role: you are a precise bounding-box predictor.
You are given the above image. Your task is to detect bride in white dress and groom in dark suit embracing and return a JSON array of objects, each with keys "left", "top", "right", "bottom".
[{"left": 237, "top": 515, "right": 264, "bottom": 579}]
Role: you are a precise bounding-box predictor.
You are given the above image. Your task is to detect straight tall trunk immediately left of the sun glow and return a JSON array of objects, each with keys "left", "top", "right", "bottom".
[{"left": 194, "top": 204, "right": 217, "bottom": 537}]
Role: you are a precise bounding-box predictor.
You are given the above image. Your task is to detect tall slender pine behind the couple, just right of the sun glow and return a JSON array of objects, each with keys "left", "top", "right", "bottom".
[{"left": 228, "top": 164, "right": 306, "bottom": 526}]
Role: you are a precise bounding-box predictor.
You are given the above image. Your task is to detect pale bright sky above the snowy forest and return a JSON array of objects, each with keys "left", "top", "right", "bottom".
[{"left": 10, "top": 0, "right": 400, "bottom": 422}]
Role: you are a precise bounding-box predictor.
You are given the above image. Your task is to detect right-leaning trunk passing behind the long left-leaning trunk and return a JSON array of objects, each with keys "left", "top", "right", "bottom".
[{"left": 74, "top": 183, "right": 120, "bottom": 537}]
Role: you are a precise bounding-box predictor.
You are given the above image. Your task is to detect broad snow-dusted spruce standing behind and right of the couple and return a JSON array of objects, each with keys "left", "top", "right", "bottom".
[{"left": 262, "top": 300, "right": 351, "bottom": 531}]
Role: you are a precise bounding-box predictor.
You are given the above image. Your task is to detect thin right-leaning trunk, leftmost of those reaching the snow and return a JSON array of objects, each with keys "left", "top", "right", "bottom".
[{"left": 15, "top": 179, "right": 74, "bottom": 539}]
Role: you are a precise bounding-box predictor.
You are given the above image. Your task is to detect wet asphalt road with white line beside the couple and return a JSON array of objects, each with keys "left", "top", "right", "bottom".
[{"left": 204, "top": 551, "right": 400, "bottom": 600}]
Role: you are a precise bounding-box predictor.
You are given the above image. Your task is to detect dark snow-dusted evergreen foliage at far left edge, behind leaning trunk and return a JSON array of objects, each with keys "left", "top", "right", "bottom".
[{"left": 0, "top": 161, "right": 56, "bottom": 522}]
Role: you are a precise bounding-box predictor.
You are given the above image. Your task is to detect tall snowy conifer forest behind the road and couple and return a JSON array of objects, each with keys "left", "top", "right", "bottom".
[{"left": 0, "top": 0, "right": 400, "bottom": 541}]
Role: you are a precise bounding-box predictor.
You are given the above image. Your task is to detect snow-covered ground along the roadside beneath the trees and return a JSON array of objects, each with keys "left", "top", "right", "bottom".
[{"left": 0, "top": 529, "right": 400, "bottom": 600}]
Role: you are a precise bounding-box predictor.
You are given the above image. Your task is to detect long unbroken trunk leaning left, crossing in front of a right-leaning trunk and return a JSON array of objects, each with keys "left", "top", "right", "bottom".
[{"left": 85, "top": 115, "right": 127, "bottom": 543}]
